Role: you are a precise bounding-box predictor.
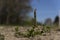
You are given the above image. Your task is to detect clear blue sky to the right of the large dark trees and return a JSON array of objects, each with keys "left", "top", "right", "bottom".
[{"left": 31, "top": 0, "right": 60, "bottom": 22}]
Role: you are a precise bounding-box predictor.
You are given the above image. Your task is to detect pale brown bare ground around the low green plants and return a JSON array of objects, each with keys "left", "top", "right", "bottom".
[{"left": 0, "top": 26, "right": 60, "bottom": 40}]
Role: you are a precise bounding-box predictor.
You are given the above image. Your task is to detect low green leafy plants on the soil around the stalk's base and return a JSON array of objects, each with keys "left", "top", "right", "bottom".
[{"left": 15, "top": 27, "right": 45, "bottom": 38}]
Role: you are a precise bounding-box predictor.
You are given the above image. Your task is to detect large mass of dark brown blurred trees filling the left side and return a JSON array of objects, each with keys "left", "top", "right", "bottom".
[{"left": 0, "top": 0, "right": 32, "bottom": 24}]
